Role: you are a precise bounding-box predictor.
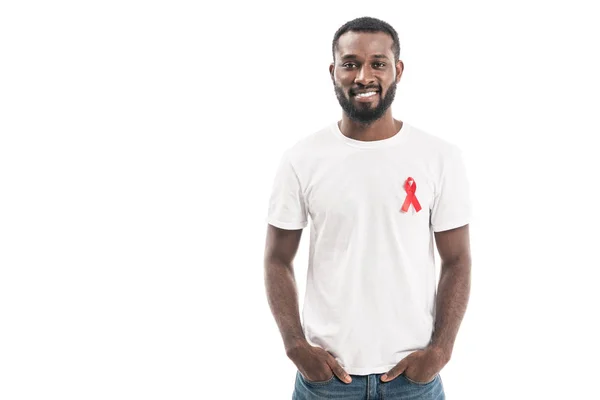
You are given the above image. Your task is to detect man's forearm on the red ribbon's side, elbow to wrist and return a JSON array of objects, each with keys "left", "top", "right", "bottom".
[{"left": 430, "top": 260, "right": 471, "bottom": 360}]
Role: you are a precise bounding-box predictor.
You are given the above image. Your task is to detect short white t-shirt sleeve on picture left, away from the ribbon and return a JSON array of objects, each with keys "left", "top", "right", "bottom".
[{"left": 266, "top": 152, "right": 308, "bottom": 230}]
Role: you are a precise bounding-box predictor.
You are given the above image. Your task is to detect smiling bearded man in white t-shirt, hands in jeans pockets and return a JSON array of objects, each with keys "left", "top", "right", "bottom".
[{"left": 265, "top": 17, "right": 471, "bottom": 400}]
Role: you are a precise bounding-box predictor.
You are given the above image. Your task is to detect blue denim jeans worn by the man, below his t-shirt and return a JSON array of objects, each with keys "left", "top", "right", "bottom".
[{"left": 292, "top": 371, "right": 446, "bottom": 400}]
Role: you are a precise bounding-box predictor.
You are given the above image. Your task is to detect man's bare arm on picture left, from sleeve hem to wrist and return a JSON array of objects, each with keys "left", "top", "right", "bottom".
[{"left": 264, "top": 224, "right": 306, "bottom": 356}]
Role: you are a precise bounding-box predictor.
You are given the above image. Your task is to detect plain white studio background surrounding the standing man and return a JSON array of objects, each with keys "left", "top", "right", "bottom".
[{"left": 0, "top": 1, "right": 600, "bottom": 400}]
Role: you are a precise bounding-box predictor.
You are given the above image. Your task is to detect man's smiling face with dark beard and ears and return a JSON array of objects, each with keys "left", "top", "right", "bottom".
[{"left": 329, "top": 32, "right": 404, "bottom": 125}]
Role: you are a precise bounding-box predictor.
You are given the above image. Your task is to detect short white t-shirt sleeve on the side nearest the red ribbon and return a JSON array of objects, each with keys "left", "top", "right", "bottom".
[{"left": 431, "top": 145, "right": 472, "bottom": 232}]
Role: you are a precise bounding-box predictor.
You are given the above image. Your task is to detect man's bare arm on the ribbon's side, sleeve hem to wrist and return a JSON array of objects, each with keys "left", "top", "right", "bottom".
[{"left": 430, "top": 224, "right": 471, "bottom": 362}]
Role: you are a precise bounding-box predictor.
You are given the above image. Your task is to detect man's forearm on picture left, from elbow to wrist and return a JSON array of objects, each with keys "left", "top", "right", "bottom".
[{"left": 265, "top": 260, "right": 306, "bottom": 354}]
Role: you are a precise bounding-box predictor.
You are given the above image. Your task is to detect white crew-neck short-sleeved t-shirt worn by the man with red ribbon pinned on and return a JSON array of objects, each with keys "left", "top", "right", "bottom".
[{"left": 266, "top": 122, "right": 471, "bottom": 375}]
